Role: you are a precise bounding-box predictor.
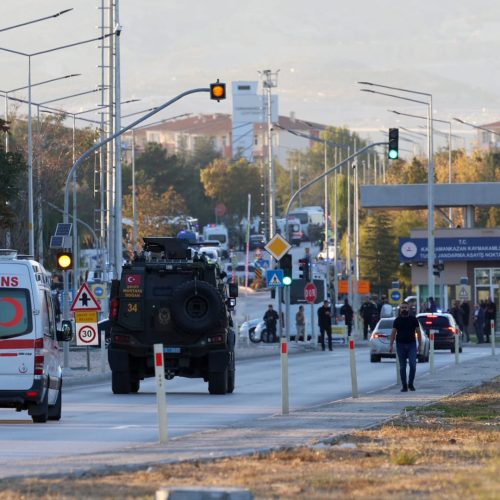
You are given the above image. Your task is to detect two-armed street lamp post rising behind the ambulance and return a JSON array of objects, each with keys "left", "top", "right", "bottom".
[{"left": 0, "top": 33, "right": 114, "bottom": 257}]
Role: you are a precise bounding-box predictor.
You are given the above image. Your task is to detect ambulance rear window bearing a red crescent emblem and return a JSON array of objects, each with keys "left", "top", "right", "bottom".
[{"left": 0, "top": 288, "right": 32, "bottom": 339}]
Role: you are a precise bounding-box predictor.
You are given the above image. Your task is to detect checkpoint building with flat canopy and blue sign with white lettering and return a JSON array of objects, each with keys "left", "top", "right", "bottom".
[{"left": 361, "top": 182, "right": 500, "bottom": 316}]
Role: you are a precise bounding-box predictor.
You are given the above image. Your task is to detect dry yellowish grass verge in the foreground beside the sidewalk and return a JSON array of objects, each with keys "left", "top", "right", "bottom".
[{"left": 0, "top": 378, "right": 500, "bottom": 500}]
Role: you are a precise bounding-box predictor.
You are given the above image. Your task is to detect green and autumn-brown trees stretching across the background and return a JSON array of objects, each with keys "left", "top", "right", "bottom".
[{"left": 0, "top": 114, "right": 500, "bottom": 293}]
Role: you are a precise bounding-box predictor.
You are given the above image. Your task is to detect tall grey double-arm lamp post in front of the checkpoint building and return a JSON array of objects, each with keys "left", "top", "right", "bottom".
[{"left": 358, "top": 82, "right": 435, "bottom": 297}]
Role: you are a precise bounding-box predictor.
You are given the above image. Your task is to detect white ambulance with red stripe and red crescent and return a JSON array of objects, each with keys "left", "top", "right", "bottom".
[{"left": 0, "top": 250, "right": 73, "bottom": 423}]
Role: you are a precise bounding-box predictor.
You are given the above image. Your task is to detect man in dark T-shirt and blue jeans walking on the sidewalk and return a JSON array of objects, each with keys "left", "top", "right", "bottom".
[{"left": 389, "top": 302, "right": 423, "bottom": 392}]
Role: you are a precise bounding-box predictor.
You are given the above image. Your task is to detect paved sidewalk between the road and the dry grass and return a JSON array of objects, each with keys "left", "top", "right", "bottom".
[{"left": 15, "top": 355, "right": 500, "bottom": 475}]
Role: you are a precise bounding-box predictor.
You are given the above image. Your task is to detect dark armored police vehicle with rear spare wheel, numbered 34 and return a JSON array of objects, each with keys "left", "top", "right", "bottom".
[{"left": 108, "top": 237, "right": 238, "bottom": 394}]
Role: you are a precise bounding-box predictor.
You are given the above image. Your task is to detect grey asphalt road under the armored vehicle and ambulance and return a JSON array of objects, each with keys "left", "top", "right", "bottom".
[{"left": 0, "top": 345, "right": 494, "bottom": 477}]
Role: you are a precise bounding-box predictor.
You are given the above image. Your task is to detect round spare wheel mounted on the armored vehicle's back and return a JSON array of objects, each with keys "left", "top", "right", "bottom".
[{"left": 170, "top": 280, "right": 226, "bottom": 334}]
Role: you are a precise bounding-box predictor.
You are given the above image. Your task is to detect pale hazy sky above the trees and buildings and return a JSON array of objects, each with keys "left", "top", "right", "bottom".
[{"left": 0, "top": 0, "right": 500, "bottom": 147}]
